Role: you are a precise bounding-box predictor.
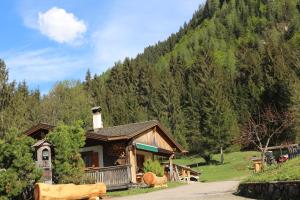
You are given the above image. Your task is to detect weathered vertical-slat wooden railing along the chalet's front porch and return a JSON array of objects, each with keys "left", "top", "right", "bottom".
[{"left": 84, "top": 165, "right": 131, "bottom": 190}]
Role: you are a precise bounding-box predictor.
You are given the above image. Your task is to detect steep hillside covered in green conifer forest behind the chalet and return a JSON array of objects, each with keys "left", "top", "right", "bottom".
[{"left": 0, "top": 0, "right": 300, "bottom": 159}]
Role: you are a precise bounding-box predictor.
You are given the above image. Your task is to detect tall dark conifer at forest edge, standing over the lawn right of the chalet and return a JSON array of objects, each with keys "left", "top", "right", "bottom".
[{"left": 188, "top": 55, "right": 238, "bottom": 162}]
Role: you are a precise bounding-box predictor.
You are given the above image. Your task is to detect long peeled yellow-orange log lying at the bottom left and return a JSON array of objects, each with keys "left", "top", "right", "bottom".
[{"left": 34, "top": 183, "right": 106, "bottom": 200}]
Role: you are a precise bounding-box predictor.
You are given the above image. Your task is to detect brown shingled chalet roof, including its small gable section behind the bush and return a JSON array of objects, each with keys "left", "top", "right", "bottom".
[{"left": 25, "top": 120, "right": 185, "bottom": 152}]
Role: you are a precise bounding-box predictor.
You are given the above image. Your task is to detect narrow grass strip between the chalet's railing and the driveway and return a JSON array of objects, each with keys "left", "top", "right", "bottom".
[{"left": 107, "top": 182, "right": 185, "bottom": 197}]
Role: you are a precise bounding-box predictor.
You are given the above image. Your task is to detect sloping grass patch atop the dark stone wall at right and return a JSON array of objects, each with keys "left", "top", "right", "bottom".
[{"left": 245, "top": 157, "right": 300, "bottom": 182}]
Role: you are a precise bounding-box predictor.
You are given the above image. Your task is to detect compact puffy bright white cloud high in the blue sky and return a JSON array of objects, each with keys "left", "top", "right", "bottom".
[{"left": 38, "top": 7, "right": 87, "bottom": 44}]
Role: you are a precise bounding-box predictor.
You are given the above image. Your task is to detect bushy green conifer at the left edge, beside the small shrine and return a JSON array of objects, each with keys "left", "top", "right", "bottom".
[{"left": 0, "top": 129, "right": 41, "bottom": 200}]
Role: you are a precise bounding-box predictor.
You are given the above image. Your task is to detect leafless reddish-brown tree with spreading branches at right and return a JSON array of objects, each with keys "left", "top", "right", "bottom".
[{"left": 241, "top": 105, "right": 294, "bottom": 164}]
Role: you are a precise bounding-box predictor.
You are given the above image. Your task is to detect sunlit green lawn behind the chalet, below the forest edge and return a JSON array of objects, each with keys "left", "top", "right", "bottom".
[{"left": 174, "top": 151, "right": 260, "bottom": 182}]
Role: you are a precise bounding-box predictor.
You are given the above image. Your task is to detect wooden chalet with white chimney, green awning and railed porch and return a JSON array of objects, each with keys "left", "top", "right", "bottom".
[{"left": 25, "top": 107, "right": 184, "bottom": 190}]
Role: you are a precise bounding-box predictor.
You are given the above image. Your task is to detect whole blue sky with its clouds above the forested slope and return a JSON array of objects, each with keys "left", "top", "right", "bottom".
[{"left": 0, "top": 0, "right": 204, "bottom": 94}]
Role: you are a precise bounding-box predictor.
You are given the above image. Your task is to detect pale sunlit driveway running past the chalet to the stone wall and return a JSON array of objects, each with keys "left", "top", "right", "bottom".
[{"left": 112, "top": 181, "right": 253, "bottom": 200}]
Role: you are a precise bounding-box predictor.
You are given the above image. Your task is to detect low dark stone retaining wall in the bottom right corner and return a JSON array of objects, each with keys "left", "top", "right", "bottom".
[{"left": 238, "top": 180, "right": 300, "bottom": 200}]
